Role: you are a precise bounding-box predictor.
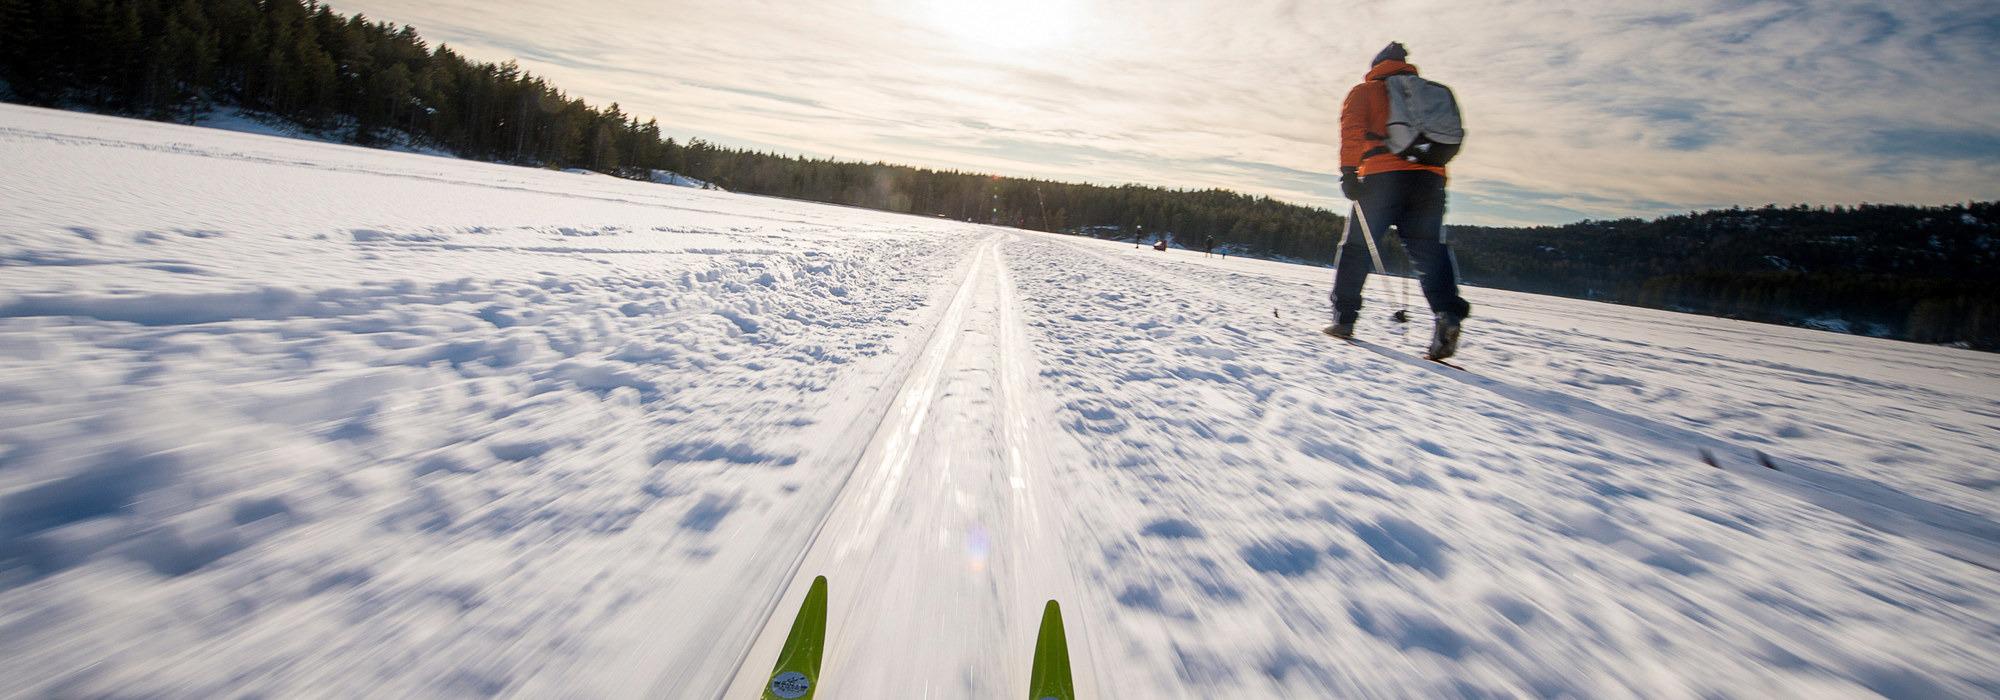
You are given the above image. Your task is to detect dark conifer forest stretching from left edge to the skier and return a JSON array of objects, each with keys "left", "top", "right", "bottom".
[{"left": 0, "top": 0, "right": 1340, "bottom": 258}]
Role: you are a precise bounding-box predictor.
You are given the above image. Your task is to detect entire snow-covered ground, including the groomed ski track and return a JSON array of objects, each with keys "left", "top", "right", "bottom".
[{"left": 0, "top": 106, "right": 2000, "bottom": 698}]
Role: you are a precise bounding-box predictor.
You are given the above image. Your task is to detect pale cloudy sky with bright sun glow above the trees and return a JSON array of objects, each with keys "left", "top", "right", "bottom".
[{"left": 332, "top": 0, "right": 2000, "bottom": 226}]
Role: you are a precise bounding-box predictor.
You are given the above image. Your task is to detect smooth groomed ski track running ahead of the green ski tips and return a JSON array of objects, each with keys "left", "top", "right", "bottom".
[{"left": 724, "top": 236, "right": 1088, "bottom": 698}]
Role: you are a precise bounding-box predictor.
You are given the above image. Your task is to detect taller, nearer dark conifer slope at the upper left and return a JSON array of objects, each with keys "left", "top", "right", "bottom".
[{"left": 0, "top": 0, "right": 678, "bottom": 174}]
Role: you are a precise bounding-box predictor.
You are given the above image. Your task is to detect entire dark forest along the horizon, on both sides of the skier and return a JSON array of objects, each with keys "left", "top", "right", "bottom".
[{"left": 0, "top": 0, "right": 2000, "bottom": 348}]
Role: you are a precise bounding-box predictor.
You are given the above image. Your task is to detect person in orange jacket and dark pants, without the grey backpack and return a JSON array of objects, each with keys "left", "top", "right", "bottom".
[{"left": 1326, "top": 42, "right": 1472, "bottom": 360}]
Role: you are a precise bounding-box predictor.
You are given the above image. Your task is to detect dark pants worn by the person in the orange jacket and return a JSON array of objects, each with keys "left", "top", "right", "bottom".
[{"left": 1332, "top": 170, "right": 1472, "bottom": 322}]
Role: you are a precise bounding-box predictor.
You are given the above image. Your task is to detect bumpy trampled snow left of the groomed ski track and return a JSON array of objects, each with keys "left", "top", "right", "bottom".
[{"left": 0, "top": 108, "right": 984, "bottom": 694}]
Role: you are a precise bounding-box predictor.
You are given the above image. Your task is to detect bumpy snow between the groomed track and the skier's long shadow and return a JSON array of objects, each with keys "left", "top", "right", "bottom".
[{"left": 1012, "top": 240, "right": 1994, "bottom": 696}]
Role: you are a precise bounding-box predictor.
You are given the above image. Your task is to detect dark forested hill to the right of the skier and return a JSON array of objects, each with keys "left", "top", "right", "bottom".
[{"left": 1452, "top": 202, "right": 2000, "bottom": 350}]
